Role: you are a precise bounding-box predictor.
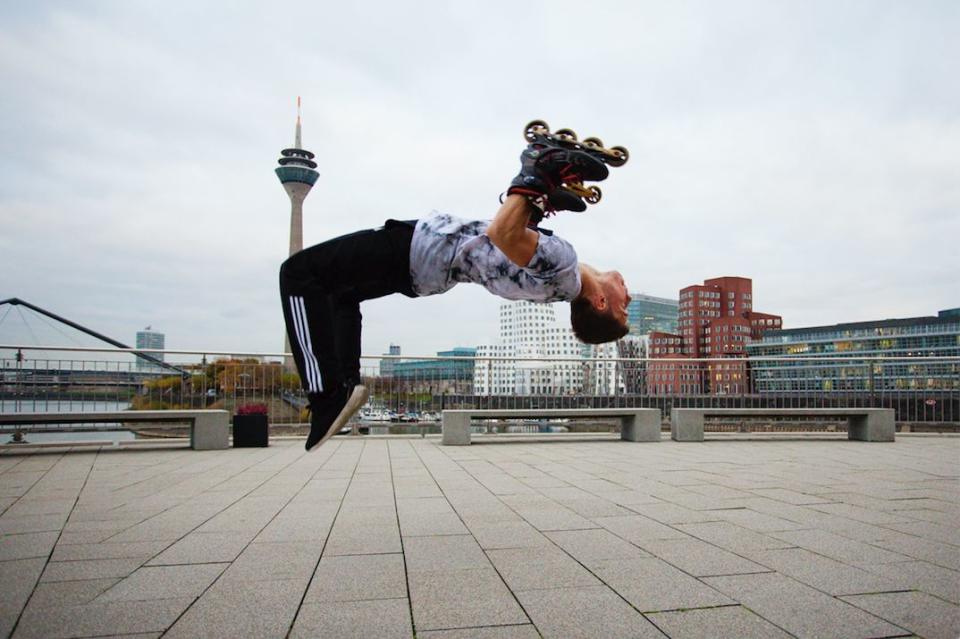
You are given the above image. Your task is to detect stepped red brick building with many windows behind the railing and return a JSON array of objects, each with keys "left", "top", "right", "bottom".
[{"left": 647, "top": 277, "right": 782, "bottom": 395}]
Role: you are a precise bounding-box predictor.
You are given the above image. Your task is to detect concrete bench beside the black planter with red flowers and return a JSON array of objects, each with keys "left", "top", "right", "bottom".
[{"left": 0, "top": 410, "right": 230, "bottom": 450}]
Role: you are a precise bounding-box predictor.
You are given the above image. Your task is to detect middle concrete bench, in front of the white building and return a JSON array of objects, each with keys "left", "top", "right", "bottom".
[{"left": 442, "top": 408, "right": 661, "bottom": 446}]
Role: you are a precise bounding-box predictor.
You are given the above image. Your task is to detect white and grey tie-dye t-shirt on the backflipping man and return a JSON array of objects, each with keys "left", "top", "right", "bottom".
[{"left": 410, "top": 212, "right": 580, "bottom": 302}]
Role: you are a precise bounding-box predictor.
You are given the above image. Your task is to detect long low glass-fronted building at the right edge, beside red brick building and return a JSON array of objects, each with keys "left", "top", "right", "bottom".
[{"left": 747, "top": 309, "right": 960, "bottom": 393}]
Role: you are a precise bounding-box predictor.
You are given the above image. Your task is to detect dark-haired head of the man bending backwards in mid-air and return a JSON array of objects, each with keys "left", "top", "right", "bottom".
[{"left": 570, "top": 265, "right": 630, "bottom": 344}]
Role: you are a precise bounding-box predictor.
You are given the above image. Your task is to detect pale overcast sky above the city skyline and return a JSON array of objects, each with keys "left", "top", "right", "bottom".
[{"left": 0, "top": 0, "right": 960, "bottom": 355}]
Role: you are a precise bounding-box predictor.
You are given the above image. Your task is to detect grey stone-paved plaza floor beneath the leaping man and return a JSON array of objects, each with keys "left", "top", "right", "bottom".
[{"left": 0, "top": 435, "right": 960, "bottom": 639}]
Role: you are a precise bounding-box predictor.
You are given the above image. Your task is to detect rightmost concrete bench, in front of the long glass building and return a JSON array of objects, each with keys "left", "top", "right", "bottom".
[{"left": 670, "top": 408, "right": 896, "bottom": 442}]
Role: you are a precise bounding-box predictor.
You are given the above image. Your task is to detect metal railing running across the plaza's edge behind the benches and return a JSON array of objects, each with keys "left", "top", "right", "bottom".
[{"left": 0, "top": 345, "right": 960, "bottom": 440}]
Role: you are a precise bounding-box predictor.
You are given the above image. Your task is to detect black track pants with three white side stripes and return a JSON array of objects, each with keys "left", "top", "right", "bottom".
[{"left": 280, "top": 220, "right": 416, "bottom": 402}]
